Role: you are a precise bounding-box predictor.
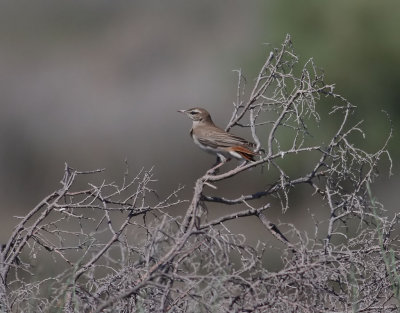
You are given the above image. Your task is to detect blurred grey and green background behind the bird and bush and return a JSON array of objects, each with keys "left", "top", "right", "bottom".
[{"left": 0, "top": 0, "right": 400, "bottom": 258}]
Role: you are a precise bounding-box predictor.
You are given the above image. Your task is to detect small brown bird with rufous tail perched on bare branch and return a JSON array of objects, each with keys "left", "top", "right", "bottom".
[{"left": 178, "top": 108, "right": 258, "bottom": 162}]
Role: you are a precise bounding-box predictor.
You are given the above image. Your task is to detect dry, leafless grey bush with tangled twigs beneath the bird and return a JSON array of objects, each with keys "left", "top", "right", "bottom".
[{"left": 0, "top": 36, "right": 400, "bottom": 312}]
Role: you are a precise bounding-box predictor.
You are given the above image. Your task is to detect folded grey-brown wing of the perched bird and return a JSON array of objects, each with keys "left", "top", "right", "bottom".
[{"left": 197, "top": 128, "right": 255, "bottom": 148}]
